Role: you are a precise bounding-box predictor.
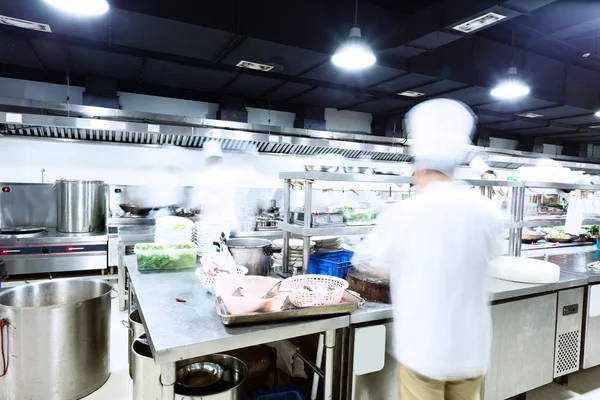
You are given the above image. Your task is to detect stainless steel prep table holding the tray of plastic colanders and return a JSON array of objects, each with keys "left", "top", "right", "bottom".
[{"left": 124, "top": 255, "right": 350, "bottom": 400}]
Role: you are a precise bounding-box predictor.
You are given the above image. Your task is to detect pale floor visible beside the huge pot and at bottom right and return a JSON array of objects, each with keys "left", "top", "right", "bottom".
[{"left": 85, "top": 300, "right": 600, "bottom": 400}]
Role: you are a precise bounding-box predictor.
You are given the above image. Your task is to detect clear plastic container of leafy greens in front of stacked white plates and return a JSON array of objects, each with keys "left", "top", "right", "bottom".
[{"left": 134, "top": 243, "right": 198, "bottom": 271}]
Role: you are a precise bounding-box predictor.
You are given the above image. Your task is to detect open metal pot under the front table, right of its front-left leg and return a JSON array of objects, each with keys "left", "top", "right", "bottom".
[{"left": 175, "top": 354, "right": 248, "bottom": 400}]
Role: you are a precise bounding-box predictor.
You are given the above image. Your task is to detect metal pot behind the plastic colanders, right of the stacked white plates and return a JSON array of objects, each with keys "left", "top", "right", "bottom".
[{"left": 227, "top": 239, "right": 281, "bottom": 276}]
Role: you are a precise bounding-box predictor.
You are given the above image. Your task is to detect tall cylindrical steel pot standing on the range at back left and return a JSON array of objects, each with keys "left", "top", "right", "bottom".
[{"left": 54, "top": 179, "right": 106, "bottom": 233}]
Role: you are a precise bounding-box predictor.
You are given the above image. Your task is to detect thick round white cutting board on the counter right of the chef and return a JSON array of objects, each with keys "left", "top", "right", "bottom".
[{"left": 488, "top": 256, "right": 560, "bottom": 284}]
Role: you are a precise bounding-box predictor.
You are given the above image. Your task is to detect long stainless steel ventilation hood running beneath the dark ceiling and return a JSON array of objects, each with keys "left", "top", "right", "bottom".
[{"left": 0, "top": 97, "right": 600, "bottom": 174}]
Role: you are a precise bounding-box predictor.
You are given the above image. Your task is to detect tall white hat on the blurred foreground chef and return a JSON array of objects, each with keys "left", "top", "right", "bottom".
[{"left": 405, "top": 99, "right": 477, "bottom": 175}]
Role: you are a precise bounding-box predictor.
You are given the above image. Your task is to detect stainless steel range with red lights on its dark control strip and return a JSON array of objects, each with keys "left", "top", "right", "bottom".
[{"left": 0, "top": 228, "right": 108, "bottom": 275}]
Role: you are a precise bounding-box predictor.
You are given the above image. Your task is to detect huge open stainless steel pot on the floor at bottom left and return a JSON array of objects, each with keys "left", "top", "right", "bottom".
[{"left": 0, "top": 279, "right": 112, "bottom": 400}]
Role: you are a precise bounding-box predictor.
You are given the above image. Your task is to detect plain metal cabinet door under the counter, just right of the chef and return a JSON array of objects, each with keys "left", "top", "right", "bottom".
[{"left": 484, "top": 293, "right": 557, "bottom": 400}]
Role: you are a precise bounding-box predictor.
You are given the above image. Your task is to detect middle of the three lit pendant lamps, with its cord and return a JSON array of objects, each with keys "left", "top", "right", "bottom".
[{"left": 331, "top": 0, "right": 377, "bottom": 71}]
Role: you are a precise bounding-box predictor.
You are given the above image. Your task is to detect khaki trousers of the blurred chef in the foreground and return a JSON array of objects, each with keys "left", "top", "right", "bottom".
[{"left": 398, "top": 365, "right": 483, "bottom": 400}]
